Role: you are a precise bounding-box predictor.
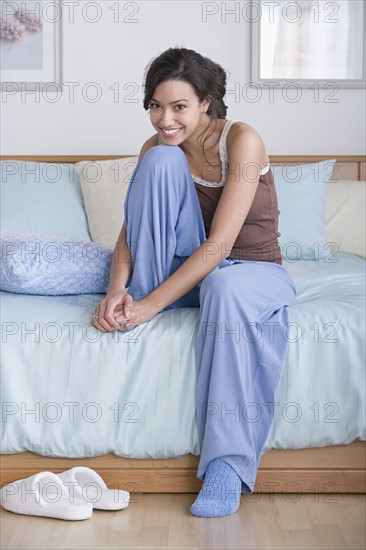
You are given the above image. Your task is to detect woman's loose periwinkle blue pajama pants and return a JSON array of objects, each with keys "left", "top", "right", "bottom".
[{"left": 124, "top": 145, "right": 296, "bottom": 493}]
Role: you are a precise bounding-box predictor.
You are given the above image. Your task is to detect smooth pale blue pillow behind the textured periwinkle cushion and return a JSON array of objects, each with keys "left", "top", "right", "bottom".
[{"left": 0, "top": 160, "right": 91, "bottom": 241}]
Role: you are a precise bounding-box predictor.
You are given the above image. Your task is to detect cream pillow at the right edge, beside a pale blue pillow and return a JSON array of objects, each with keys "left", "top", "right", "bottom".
[{"left": 324, "top": 180, "right": 366, "bottom": 258}]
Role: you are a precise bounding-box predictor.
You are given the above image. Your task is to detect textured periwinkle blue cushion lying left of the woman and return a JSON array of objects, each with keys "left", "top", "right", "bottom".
[{"left": 0, "top": 234, "right": 113, "bottom": 296}]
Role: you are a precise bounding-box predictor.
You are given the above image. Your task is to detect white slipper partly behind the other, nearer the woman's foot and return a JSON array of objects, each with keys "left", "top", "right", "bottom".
[{"left": 58, "top": 466, "right": 130, "bottom": 510}]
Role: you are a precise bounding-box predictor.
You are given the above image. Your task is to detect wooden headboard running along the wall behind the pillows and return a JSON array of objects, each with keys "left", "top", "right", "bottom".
[{"left": 0, "top": 154, "right": 366, "bottom": 181}]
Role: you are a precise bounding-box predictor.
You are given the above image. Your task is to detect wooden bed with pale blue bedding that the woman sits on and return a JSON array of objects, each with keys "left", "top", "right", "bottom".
[{"left": 0, "top": 156, "right": 366, "bottom": 493}]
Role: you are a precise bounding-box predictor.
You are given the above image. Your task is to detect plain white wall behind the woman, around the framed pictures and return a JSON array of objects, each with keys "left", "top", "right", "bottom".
[{"left": 1, "top": 0, "right": 366, "bottom": 155}]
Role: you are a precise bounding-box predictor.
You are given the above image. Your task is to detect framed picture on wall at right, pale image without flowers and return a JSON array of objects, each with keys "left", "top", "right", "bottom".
[{"left": 251, "top": 0, "right": 366, "bottom": 88}]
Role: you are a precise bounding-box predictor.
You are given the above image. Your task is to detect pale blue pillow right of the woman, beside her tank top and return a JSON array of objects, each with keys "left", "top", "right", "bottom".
[{"left": 272, "top": 159, "right": 336, "bottom": 262}]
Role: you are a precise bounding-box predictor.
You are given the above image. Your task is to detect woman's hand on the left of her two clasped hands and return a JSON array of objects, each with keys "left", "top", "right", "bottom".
[{"left": 92, "top": 289, "right": 133, "bottom": 332}]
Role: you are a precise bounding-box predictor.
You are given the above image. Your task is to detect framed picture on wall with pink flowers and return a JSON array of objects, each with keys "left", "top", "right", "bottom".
[{"left": 0, "top": 0, "right": 62, "bottom": 91}]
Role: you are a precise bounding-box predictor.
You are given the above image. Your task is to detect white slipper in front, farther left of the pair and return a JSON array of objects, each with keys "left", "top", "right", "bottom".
[{"left": 0, "top": 472, "right": 93, "bottom": 521}]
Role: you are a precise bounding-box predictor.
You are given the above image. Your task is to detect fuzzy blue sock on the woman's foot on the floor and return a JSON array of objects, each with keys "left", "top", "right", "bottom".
[{"left": 190, "top": 458, "right": 241, "bottom": 518}]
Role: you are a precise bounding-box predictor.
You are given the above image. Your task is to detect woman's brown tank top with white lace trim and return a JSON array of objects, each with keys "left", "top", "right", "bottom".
[{"left": 192, "top": 120, "right": 282, "bottom": 265}]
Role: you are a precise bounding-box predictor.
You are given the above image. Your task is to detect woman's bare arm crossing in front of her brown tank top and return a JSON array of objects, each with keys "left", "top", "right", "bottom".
[{"left": 145, "top": 123, "right": 268, "bottom": 313}]
